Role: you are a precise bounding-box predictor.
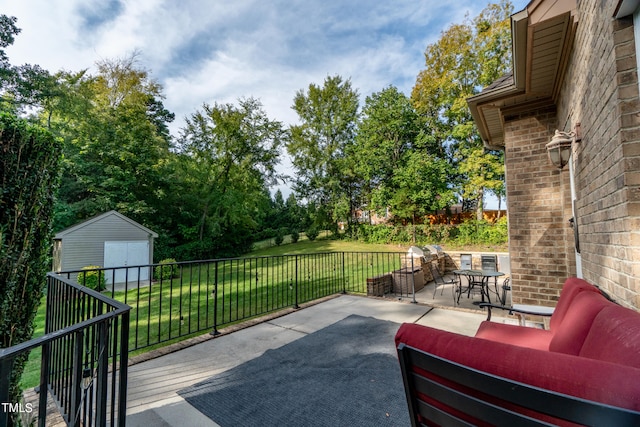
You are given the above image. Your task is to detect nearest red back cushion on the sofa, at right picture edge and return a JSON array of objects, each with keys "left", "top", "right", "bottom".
[{"left": 580, "top": 304, "right": 640, "bottom": 368}]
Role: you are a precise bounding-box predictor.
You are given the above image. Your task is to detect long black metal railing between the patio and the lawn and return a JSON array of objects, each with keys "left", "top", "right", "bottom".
[{"left": 59, "top": 252, "right": 411, "bottom": 351}]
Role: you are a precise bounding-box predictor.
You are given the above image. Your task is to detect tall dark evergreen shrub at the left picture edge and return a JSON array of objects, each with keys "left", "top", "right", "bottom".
[{"left": 0, "top": 113, "right": 62, "bottom": 418}]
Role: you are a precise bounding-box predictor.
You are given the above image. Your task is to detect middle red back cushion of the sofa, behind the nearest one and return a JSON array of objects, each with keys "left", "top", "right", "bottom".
[{"left": 549, "top": 292, "right": 614, "bottom": 356}]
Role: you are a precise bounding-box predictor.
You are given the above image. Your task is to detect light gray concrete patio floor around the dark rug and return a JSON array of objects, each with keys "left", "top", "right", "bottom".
[{"left": 127, "top": 283, "right": 511, "bottom": 427}]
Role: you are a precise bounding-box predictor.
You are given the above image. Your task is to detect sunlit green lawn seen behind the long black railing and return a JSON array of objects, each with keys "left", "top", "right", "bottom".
[{"left": 112, "top": 240, "right": 404, "bottom": 351}]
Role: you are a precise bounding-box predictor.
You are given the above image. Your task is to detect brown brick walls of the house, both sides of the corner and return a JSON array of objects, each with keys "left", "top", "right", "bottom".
[{"left": 504, "top": 0, "right": 640, "bottom": 309}]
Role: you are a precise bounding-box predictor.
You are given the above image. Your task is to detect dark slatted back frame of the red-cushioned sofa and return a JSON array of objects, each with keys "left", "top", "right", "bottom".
[{"left": 397, "top": 343, "right": 640, "bottom": 426}]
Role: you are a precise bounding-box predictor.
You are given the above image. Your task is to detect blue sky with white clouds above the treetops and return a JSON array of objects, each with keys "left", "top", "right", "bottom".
[{"left": 0, "top": 0, "right": 528, "bottom": 207}]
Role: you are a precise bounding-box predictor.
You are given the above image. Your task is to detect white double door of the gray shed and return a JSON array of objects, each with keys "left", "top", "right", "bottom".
[{"left": 103, "top": 240, "right": 149, "bottom": 283}]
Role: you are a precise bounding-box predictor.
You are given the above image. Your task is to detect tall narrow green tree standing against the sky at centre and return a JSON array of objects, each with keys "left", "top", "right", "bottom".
[{"left": 287, "top": 76, "right": 358, "bottom": 230}]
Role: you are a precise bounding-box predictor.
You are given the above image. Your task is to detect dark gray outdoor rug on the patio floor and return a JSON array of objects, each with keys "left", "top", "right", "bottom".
[{"left": 179, "top": 315, "right": 410, "bottom": 427}]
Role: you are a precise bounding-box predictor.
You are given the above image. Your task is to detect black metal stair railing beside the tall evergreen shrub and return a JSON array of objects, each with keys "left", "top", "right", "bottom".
[{"left": 0, "top": 273, "right": 131, "bottom": 426}]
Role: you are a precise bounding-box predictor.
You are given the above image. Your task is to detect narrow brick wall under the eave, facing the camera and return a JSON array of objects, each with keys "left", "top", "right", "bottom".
[{"left": 505, "top": 108, "right": 575, "bottom": 305}]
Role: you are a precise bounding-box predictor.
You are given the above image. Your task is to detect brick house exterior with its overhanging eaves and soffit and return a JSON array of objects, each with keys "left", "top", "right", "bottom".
[{"left": 468, "top": 0, "right": 640, "bottom": 309}]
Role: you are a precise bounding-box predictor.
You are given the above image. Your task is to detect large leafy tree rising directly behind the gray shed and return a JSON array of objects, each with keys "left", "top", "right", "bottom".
[{"left": 49, "top": 55, "right": 173, "bottom": 231}]
